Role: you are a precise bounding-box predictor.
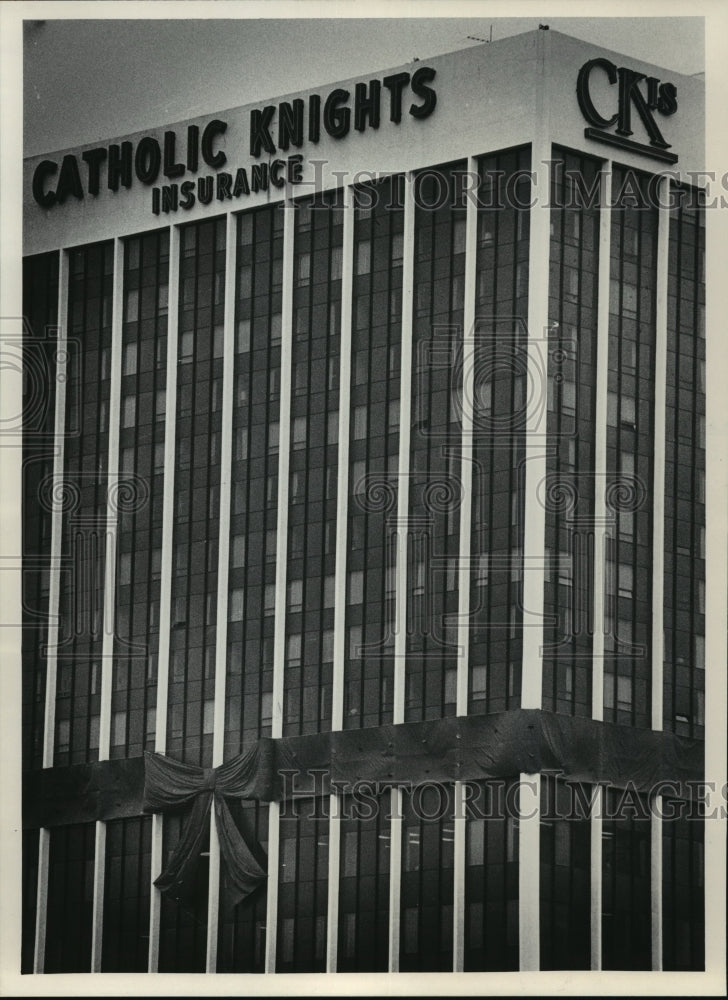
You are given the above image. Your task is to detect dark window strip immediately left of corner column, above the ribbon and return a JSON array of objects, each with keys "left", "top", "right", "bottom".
[{"left": 468, "top": 148, "right": 531, "bottom": 713}]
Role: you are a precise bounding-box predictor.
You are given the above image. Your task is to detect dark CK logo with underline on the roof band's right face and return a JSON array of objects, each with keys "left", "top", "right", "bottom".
[{"left": 576, "top": 58, "right": 677, "bottom": 163}]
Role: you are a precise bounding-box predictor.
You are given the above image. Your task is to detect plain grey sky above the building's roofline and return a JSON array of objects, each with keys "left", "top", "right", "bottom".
[{"left": 23, "top": 8, "right": 704, "bottom": 156}]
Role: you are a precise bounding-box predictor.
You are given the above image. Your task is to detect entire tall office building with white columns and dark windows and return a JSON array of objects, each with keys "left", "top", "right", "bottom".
[{"left": 22, "top": 31, "right": 706, "bottom": 973}]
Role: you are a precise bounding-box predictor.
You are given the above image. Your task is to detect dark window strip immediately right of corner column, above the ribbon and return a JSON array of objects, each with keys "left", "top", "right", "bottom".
[{"left": 543, "top": 150, "right": 601, "bottom": 720}]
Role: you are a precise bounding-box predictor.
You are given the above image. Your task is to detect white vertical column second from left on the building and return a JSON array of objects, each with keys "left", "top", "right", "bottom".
[{"left": 91, "top": 238, "right": 124, "bottom": 972}]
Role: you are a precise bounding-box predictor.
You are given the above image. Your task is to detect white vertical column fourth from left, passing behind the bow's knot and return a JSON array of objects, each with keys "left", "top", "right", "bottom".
[{"left": 205, "top": 212, "right": 238, "bottom": 972}]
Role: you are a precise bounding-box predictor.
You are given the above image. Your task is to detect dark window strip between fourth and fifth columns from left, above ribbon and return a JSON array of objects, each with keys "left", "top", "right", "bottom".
[{"left": 225, "top": 205, "right": 283, "bottom": 756}]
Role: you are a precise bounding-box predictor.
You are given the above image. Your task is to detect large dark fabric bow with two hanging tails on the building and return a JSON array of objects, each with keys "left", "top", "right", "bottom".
[{"left": 144, "top": 741, "right": 272, "bottom": 906}]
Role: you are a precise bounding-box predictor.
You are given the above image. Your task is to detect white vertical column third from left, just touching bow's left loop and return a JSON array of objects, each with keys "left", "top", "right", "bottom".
[{"left": 149, "top": 226, "right": 180, "bottom": 972}]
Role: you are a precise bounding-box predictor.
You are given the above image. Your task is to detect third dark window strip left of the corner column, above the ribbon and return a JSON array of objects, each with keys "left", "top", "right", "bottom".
[{"left": 342, "top": 177, "right": 404, "bottom": 732}]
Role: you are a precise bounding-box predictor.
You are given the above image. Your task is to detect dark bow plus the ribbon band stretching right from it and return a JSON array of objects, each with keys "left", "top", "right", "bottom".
[{"left": 139, "top": 709, "right": 704, "bottom": 903}]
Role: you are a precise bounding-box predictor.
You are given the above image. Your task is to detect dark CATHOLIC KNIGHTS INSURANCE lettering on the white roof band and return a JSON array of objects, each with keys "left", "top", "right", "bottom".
[{"left": 32, "top": 66, "right": 437, "bottom": 215}]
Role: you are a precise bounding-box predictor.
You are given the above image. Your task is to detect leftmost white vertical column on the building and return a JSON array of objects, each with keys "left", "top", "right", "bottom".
[{"left": 33, "top": 250, "right": 69, "bottom": 973}]
